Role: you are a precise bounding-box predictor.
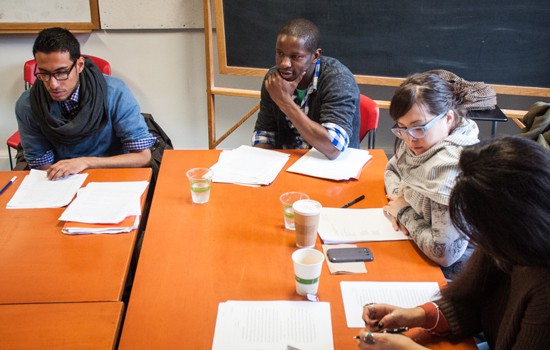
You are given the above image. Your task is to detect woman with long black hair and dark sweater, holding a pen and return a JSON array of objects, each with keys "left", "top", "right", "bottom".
[{"left": 358, "top": 137, "right": 550, "bottom": 349}]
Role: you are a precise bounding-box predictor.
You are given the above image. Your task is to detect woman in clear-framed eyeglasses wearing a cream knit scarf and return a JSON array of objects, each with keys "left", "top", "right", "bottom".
[{"left": 384, "top": 72, "right": 479, "bottom": 279}]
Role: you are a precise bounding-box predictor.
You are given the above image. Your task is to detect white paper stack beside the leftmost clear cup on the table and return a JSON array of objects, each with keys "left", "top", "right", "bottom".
[{"left": 210, "top": 146, "right": 290, "bottom": 185}]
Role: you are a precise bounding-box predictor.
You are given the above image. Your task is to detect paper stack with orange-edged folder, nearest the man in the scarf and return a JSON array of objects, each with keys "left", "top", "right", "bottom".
[{"left": 59, "top": 181, "right": 148, "bottom": 233}]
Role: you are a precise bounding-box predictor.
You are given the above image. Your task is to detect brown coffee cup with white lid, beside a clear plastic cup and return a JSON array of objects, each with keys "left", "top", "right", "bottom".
[{"left": 292, "top": 199, "right": 322, "bottom": 248}]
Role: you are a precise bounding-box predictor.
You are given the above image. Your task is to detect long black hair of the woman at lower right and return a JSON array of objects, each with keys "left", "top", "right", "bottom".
[{"left": 449, "top": 136, "right": 550, "bottom": 266}]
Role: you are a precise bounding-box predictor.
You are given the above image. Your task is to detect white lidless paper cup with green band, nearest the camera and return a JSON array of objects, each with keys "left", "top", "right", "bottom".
[{"left": 292, "top": 248, "right": 325, "bottom": 296}]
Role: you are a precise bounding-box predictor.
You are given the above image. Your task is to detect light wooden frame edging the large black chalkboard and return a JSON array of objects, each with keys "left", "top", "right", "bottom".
[{"left": 214, "top": 0, "right": 550, "bottom": 97}]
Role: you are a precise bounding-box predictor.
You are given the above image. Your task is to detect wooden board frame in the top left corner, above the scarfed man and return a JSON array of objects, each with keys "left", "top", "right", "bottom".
[{"left": 0, "top": 0, "right": 100, "bottom": 34}]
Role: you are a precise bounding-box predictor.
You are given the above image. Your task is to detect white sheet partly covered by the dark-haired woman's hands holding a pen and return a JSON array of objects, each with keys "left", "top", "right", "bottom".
[{"left": 340, "top": 281, "right": 439, "bottom": 328}]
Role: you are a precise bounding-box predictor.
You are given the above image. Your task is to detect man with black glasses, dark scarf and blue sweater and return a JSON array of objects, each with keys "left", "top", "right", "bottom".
[{"left": 15, "top": 28, "right": 156, "bottom": 180}]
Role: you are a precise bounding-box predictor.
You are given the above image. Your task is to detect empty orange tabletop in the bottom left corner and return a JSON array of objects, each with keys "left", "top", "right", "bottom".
[{"left": 0, "top": 302, "right": 124, "bottom": 350}]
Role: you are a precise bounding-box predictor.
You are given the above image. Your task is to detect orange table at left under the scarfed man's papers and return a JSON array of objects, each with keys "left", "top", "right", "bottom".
[{"left": 0, "top": 168, "right": 151, "bottom": 304}]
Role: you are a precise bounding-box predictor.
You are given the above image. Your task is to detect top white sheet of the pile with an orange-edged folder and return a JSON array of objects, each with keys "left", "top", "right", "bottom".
[{"left": 59, "top": 181, "right": 149, "bottom": 224}]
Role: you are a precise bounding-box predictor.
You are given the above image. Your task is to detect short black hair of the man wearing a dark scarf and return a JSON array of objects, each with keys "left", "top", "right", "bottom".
[{"left": 32, "top": 27, "right": 80, "bottom": 61}]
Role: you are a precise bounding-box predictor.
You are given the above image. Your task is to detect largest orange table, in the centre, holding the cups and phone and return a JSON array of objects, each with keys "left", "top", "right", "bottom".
[{"left": 119, "top": 150, "right": 478, "bottom": 349}]
